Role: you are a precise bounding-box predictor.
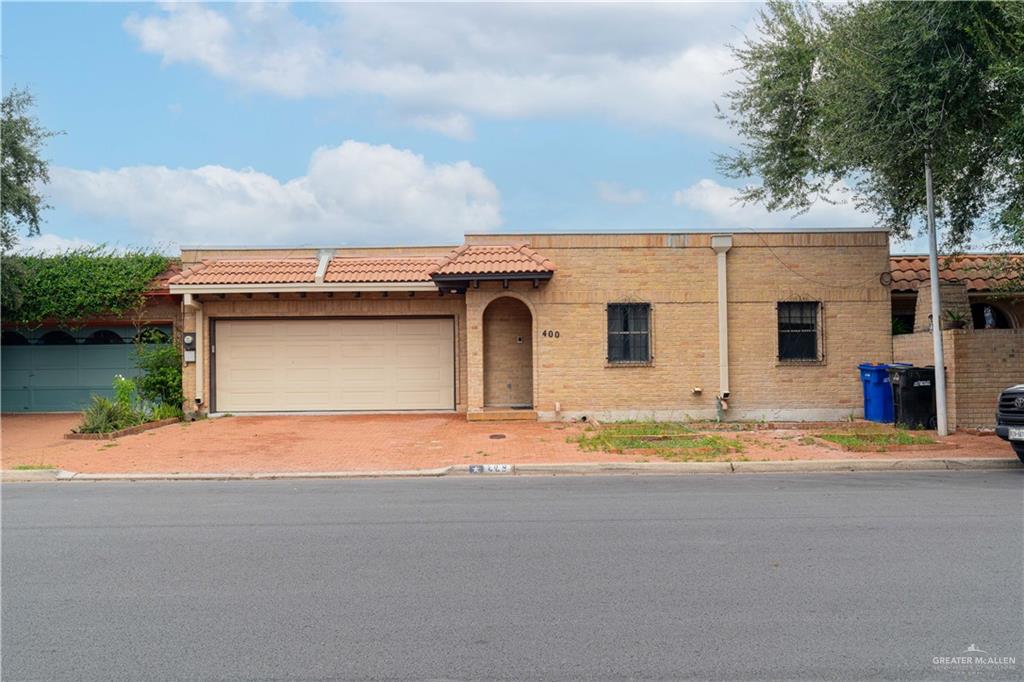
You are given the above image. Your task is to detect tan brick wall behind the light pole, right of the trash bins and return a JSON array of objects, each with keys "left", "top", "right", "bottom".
[{"left": 893, "top": 329, "right": 1024, "bottom": 428}]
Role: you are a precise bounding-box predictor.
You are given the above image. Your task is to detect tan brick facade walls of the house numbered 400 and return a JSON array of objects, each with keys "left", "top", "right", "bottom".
[{"left": 183, "top": 231, "right": 892, "bottom": 419}]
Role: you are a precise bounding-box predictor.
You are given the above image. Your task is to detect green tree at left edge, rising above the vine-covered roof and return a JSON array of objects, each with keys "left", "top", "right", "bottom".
[{"left": 0, "top": 88, "right": 59, "bottom": 251}]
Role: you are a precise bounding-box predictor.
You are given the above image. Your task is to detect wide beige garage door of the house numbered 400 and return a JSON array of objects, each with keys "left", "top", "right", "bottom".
[{"left": 213, "top": 317, "right": 455, "bottom": 412}]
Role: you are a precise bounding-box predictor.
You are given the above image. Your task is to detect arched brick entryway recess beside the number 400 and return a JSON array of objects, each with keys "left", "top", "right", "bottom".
[{"left": 483, "top": 296, "right": 534, "bottom": 409}]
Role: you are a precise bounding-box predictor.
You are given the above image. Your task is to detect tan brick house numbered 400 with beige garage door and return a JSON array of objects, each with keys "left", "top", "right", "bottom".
[{"left": 170, "top": 229, "right": 892, "bottom": 420}]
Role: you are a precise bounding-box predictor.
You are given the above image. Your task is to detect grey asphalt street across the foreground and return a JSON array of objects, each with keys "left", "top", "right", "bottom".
[{"left": 0, "top": 470, "right": 1024, "bottom": 680}]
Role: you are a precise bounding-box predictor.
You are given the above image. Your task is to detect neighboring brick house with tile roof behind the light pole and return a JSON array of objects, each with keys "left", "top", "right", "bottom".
[{"left": 892, "top": 254, "right": 1024, "bottom": 428}]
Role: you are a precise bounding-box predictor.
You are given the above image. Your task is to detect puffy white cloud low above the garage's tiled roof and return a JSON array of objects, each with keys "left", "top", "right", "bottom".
[{"left": 49, "top": 140, "right": 501, "bottom": 244}]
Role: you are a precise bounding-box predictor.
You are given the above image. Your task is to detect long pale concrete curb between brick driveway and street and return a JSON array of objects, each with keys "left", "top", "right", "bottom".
[{"left": 0, "top": 458, "right": 1024, "bottom": 482}]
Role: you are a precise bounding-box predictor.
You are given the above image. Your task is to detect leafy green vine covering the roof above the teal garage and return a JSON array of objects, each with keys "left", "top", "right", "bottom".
[{"left": 0, "top": 247, "right": 170, "bottom": 326}]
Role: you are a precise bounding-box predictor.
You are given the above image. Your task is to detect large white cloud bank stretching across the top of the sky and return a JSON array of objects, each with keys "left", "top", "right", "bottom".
[{"left": 125, "top": 3, "right": 752, "bottom": 136}]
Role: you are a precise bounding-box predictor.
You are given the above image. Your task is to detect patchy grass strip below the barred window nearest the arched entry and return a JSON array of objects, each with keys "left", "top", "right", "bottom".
[{"left": 572, "top": 422, "right": 742, "bottom": 461}]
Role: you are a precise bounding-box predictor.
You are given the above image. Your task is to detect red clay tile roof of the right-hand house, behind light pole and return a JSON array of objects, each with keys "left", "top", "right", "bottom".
[{"left": 889, "top": 254, "right": 1024, "bottom": 291}]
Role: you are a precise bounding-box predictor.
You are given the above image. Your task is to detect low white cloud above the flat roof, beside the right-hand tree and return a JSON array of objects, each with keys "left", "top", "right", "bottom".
[{"left": 672, "top": 178, "right": 874, "bottom": 228}]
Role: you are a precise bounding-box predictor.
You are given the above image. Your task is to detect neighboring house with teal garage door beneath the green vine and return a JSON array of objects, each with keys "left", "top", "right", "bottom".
[{"left": 0, "top": 267, "right": 181, "bottom": 413}]
